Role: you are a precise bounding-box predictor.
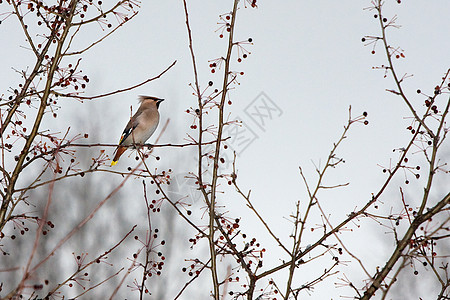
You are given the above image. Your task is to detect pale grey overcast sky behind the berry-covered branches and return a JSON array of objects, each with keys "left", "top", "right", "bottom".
[{"left": 0, "top": 0, "right": 450, "bottom": 299}]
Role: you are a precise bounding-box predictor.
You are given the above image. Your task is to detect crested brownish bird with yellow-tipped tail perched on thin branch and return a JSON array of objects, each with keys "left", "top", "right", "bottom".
[{"left": 111, "top": 96, "right": 164, "bottom": 166}]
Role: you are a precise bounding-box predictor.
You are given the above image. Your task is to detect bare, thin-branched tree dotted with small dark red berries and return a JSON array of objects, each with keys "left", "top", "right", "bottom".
[{"left": 0, "top": 0, "right": 450, "bottom": 299}]
